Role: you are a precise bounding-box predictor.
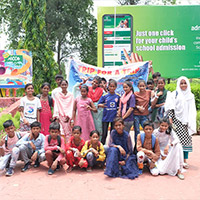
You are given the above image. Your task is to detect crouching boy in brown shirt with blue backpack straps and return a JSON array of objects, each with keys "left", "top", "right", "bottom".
[{"left": 137, "top": 121, "right": 160, "bottom": 176}]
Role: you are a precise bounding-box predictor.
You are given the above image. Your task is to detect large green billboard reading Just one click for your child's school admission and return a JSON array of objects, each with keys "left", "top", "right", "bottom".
[{"left": 98, "top": 6, "right": 200, "bottom": 78}]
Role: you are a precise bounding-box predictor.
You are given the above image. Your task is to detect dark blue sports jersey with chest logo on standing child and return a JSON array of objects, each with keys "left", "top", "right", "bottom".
[{"left": 99, "top": 92, "right": 120, "bottom": 122}]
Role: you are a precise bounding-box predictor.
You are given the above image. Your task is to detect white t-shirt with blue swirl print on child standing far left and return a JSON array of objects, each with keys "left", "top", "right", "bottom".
[{"left": 20, "top": 96, "right": 42, "bottom": 124}]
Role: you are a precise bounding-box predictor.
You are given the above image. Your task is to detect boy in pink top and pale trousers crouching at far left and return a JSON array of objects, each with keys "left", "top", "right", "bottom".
[{"left": 0, "top": 120, "right": 21, "bottom": 176}]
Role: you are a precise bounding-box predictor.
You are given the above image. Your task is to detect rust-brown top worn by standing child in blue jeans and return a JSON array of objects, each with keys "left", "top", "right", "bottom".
[{"left": 133, "top": 90, "right": 151, "bottom": 116}]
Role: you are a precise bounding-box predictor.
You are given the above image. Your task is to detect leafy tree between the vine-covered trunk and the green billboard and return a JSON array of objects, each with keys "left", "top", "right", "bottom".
[{"left": 46, "top": 0, "right": 97, "bottom": 69}]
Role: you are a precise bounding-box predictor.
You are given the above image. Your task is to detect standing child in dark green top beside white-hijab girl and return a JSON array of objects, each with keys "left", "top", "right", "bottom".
[{"left": 151, "top": 77, "right": 167, "bottom": 128}]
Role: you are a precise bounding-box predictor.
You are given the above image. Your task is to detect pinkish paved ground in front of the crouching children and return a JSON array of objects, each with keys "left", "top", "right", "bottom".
[{"left": 0, "top": 136, "right": 200, "bottom": 200}]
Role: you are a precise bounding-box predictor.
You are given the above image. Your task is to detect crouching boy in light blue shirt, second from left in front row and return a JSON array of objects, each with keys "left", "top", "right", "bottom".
[{"left": 16, "top": 121, "right": 45, "bottom": 172}]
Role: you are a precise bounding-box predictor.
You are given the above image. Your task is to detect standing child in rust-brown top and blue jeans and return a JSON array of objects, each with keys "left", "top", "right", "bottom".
[{"left": 133, "top": 80, "right": 151, "bottom": 143}]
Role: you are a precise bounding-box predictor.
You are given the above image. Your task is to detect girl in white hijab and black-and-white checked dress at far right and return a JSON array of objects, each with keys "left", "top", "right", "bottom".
[{"left": 165, "top": 76, "right": 196, "bottom": 169}]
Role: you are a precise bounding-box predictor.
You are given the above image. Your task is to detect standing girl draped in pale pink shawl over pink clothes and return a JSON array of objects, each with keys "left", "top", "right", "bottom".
[{"left": 53, "top": 80, "right": 74, "bottom": 141}]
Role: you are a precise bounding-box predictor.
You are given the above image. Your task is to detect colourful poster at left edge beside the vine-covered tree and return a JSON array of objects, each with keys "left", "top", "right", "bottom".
[{"left": 0, "top": 49, "right": 32, "bottom": 88}]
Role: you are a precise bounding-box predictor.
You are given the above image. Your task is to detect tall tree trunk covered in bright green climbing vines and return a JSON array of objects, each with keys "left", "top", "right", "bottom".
[{"left": 18, "top": 0, "right": 57, "bottom": 91}]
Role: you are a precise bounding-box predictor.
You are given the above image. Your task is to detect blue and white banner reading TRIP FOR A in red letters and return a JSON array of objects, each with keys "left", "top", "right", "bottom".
[{"left": 68, "top": 60, "right": 149, "bottom": 95}]
